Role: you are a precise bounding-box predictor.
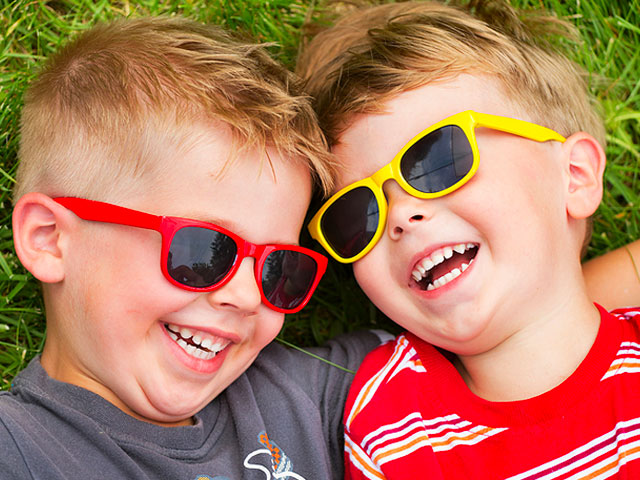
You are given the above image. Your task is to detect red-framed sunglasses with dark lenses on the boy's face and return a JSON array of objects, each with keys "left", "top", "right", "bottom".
[{"left": 54, "top": 197, "right": 327, "bottom": 313}]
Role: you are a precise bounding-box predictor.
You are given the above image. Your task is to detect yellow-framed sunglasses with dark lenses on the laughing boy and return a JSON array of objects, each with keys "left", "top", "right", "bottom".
[{"left": 309, "top": 110, "right": 565, "bottom": 263}]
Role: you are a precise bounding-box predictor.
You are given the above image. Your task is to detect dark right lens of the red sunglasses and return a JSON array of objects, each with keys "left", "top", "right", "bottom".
[{"left": 262, "top": 250, "right": 318, "bottom": 310}]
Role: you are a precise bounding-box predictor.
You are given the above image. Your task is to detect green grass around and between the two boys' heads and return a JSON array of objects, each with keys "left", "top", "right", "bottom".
[{"left": 0, "top": 0, "right": 640, "bottom": 389}]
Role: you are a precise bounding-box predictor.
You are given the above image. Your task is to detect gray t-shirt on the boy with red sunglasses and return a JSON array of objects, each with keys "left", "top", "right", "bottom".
[{"left": 0, "top": 332, "right": 380, "bottom": 480}]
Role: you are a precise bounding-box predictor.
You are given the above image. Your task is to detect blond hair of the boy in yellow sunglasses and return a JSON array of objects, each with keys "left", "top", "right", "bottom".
[{"left": 298, "top": 0, "right": 605, "bottom": 146}]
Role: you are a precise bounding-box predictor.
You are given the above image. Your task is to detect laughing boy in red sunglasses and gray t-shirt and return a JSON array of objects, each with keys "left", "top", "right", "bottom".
[{"left": 0, "top": 18, "right": 379, "bottom": 480}]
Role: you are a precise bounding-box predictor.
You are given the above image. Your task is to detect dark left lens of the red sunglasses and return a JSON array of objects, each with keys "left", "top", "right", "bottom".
[{"left": 167, "top": 227, "right": 238, "bottom": 288}]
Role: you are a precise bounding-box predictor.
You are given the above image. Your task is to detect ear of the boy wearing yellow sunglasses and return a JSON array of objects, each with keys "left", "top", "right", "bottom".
[{"left": 562, "top": 132, "right": 606, "bottom": 219}]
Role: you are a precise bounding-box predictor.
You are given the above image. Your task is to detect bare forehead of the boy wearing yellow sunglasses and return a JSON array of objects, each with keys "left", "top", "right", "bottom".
[{"left": 332, "top": 74, "right": 518, "bottom": 189}]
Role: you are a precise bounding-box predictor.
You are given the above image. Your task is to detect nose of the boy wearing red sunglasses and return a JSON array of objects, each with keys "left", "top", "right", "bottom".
[{"left": 207, "top": 257, "right": 262, "bottom": 315}]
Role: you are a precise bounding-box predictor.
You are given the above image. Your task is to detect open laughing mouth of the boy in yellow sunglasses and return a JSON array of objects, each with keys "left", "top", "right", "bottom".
[{"left": 411, "top": 243, "right": 478, "bottom": 290}]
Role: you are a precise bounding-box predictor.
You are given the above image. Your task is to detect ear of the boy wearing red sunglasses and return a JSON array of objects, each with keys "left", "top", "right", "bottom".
[{"left": 12, "top": 192, "right": 68, "bottom": 283}]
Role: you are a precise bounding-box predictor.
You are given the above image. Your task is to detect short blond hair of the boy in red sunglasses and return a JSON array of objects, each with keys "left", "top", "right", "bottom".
[{"left": 14, "top": 17, "right": 334, "bottom": 201}]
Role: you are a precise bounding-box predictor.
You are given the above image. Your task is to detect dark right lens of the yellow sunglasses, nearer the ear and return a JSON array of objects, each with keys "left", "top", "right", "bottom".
[{"left": 400, "top": 125, "right": 473, "bottom": 193}]
